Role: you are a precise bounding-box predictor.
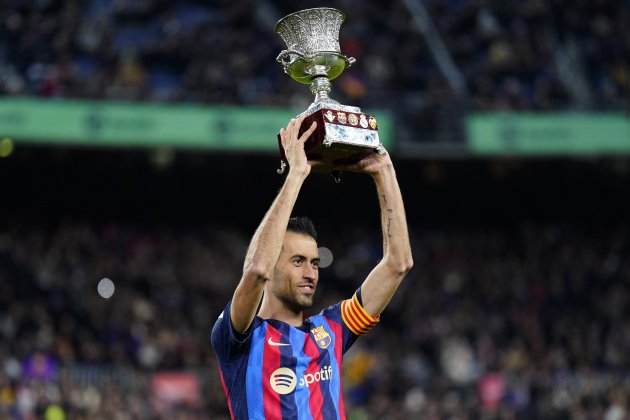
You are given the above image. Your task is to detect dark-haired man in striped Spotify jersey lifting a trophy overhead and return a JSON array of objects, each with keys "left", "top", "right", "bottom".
[{"left": 212, "top": 115, "right": 413, "bottom": 420}]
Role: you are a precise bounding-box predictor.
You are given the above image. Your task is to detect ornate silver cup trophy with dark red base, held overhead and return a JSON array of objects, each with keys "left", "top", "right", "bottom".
[{"left": 275, "top": 7, "right": 384, "bottom": 177}]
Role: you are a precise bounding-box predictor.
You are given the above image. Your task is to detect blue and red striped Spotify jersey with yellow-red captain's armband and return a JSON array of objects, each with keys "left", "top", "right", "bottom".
[{"left": 212, "top": 294, "right": 378, "bottom": 420}]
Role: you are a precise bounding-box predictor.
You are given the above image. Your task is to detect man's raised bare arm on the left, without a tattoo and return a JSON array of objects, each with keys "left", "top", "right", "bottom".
[{"left": 230, "top": 116, "right": 316, "bottom": 333}]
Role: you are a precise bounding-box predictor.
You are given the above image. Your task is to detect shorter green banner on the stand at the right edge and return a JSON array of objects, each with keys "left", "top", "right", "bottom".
[{"left": 466, "top": 113, "right": 630, "bottom": 155}]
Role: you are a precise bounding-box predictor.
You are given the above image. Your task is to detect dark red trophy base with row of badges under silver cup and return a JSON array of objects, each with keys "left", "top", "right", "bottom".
[{"left": 278, "top": 103, "right": 382, "bottom": 173}]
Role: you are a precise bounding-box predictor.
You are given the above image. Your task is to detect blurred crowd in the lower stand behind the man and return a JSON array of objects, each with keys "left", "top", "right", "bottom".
[{"left": 0, "top": 218, "right": 630, "bottom": 420}]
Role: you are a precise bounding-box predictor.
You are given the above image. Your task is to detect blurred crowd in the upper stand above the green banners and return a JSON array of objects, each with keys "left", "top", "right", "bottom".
[{"left": 0, "top": 0, "right": 630, "bottom": 116}]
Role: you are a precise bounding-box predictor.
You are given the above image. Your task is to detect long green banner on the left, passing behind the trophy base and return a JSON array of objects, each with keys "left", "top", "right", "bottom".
[{"left": 0, "top": 98, "right": 392, "bottom": 151}]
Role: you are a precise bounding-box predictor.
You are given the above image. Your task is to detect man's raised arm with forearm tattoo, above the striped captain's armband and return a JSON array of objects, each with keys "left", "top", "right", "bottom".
[{"left": 338, "top": 149, "right": 413, "bottom": 316}]
